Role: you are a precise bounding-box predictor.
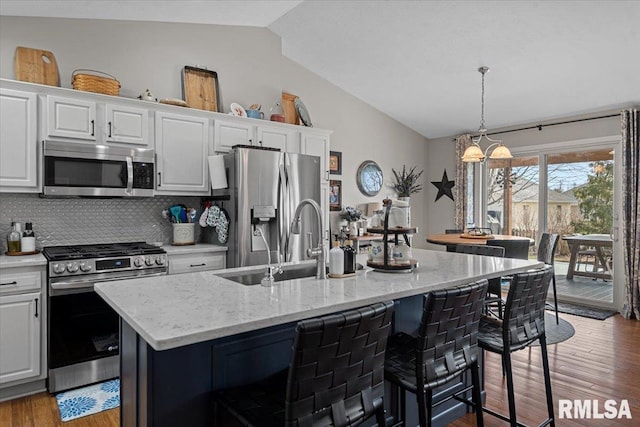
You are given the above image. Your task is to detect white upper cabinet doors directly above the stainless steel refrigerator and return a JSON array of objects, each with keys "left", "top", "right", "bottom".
[{"left": 214, "top": 119, "right": 300, "bottom": 153}]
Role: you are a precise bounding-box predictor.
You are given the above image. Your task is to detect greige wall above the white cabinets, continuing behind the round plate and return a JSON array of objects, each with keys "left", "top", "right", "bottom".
[{"left": 0, "top": 16, "right": 430, "bottom": 247}]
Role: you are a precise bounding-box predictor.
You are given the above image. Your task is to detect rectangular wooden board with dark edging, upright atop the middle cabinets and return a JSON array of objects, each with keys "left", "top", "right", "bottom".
[{"left": 182, "top": 66, "right": 222, "bottom": 112}]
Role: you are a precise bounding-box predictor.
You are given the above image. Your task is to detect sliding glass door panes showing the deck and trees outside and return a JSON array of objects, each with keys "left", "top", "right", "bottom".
[{"left": 483, "top": 146, "right": 617, "bottom": 307}]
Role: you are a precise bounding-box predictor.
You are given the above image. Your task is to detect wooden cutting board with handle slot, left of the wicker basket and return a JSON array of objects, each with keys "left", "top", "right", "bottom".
[{"left": 13, "top": 46, "right": 60, "bottom": 86}]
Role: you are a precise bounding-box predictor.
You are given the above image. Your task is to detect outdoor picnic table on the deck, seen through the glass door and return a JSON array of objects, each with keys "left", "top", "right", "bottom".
[{"left": 562, "top": 234, "right": 613, "bottom": 280}]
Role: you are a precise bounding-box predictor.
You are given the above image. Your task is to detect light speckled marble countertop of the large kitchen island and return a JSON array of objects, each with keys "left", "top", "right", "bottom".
[{"left": 95, "top": 249, "right": 543, "bottom": 350}]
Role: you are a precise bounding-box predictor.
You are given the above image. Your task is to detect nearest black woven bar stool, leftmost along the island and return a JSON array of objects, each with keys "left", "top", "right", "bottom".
[{"left": 214, "top": 301, "right": 393, "bottom": 427}]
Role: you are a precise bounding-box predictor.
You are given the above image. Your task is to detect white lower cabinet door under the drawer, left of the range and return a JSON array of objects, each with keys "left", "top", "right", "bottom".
[{"left": 0, "top": 292, "right": 42, "bottom": 384}]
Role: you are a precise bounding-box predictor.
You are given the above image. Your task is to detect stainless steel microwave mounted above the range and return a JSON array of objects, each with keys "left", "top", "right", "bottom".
[{"left": 42, "top": 141, "right": 155, "bottom": 197}]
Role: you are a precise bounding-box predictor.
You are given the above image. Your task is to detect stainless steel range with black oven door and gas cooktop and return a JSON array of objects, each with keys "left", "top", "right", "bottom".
[{"left": 42, "top": 242, "right": 167, "bottom": 393}]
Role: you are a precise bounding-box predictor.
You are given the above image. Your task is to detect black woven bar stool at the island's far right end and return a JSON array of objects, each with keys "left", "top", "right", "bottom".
[{"left": 478, "top": 266, "right": 555, "bottom": 426}]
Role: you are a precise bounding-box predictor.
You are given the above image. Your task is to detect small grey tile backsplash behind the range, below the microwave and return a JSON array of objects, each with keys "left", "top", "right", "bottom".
[{"left": 0, "top": 193, "right": 202, "bottom": 253}]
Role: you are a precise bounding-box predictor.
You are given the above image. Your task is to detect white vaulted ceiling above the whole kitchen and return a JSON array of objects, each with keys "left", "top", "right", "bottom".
[{"left": 0, "top": 0, "right": 640, "bottom": 138}]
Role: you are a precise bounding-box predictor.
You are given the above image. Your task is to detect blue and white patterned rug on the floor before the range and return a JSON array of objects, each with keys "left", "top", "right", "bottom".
[{"left": 56, "top": 379, "right": 120, "bottom": 421}]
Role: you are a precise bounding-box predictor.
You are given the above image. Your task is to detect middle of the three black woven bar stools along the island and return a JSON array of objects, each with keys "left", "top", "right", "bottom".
[{"left": 385, "top": 280, "right": 487, "bottom": 427}]
